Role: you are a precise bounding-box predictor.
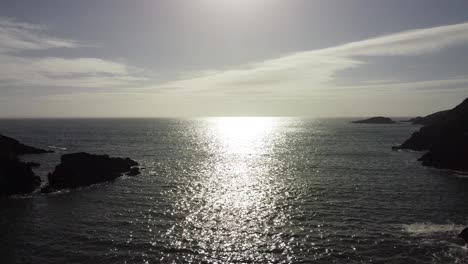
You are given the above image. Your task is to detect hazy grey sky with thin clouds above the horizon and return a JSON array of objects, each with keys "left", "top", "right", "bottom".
[{"left": 0, "top": 0, "right": 468, "bottom": 117}]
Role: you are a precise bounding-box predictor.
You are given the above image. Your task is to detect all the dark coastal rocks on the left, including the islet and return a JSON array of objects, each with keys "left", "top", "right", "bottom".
[{"left": 0, "top": 135, "right": 140, "bottom": 196}]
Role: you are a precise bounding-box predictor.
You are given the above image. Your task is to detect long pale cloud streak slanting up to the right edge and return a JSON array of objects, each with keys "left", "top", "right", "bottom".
[{"left": 156, "top": 20, "right": 468, "bottom": 96}]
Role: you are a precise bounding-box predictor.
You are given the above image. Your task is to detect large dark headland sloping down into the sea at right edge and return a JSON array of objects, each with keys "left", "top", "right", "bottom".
[{"left": 394, "top": 99, "right": 468, "bottom": 171}]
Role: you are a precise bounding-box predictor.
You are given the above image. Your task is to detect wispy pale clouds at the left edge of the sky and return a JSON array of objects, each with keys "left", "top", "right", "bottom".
[{"left": 0, "top": 17, "right": 148, "bottom": 88}]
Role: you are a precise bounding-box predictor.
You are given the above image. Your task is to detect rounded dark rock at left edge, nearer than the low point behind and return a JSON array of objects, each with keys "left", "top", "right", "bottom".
[{"left": 0, "top": 156, "right": 41, "bottom": 195}]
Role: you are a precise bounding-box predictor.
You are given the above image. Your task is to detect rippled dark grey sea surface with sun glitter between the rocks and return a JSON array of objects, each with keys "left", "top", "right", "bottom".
[{"left": 0, "top": 118, "right": 468, "bottom": 263}]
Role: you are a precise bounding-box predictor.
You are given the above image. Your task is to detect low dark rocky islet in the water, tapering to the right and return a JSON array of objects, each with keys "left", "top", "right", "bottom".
[{"left": 42, "top": 152, "right": 139, "bottom": 192}]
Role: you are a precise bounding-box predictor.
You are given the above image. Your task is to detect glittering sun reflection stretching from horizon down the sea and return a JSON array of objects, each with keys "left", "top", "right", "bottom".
[{"left": 170, "top": 117, "right": 287, "bottom": 261}]
